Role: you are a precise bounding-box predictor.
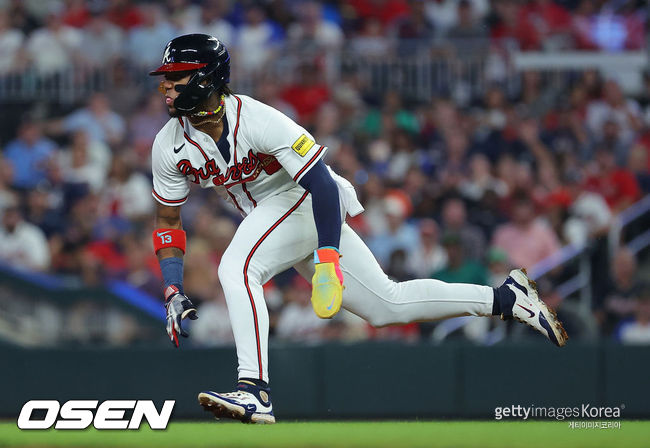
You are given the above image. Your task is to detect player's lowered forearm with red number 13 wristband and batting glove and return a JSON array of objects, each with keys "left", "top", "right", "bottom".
[{"left": 152, "top": 203, "right": 198, "bottom": 347}]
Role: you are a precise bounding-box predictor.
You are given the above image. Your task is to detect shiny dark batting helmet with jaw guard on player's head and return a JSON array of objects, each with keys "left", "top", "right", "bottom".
[{"left": 149, "top": 34, "right": 230, "bottom": 113}]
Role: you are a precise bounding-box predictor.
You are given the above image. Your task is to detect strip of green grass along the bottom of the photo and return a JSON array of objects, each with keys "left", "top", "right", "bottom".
[{"left": 0, "top": 421, "right": 650, "bottom": 448}]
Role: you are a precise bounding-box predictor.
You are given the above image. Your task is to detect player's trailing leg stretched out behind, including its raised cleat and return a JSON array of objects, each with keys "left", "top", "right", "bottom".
[{"left": 298, "top": 224, "right": 563, "bottom": 345}]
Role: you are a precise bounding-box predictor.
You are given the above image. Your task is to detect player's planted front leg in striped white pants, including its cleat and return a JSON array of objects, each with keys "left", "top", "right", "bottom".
[{"left": 199, "top": 189, "right": 317, "bottom": 423}]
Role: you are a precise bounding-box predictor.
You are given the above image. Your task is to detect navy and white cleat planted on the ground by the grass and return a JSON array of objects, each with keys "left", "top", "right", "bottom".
[{"left": 199, "top": 383, "right": 275, "bottom": 424}]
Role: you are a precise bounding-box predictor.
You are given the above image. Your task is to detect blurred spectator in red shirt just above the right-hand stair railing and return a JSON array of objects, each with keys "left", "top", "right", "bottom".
[{"left": 585, "top": 146, "right": 641, "bottom": 213}]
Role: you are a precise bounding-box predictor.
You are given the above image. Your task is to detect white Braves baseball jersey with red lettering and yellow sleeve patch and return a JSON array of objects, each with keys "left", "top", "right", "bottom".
[{"left": 152, "top": 95, "right": 363, "bottom": 216}]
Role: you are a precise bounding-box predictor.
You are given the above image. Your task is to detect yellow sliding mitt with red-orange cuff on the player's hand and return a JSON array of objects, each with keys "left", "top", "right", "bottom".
[{"left": 311, "top": 249, "right": 343, "bottom": 319}]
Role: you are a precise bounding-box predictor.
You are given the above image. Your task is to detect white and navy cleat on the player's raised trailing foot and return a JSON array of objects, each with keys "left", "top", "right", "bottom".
[{"left": 499, "top": 269, "right": 569, "bottom": 347}]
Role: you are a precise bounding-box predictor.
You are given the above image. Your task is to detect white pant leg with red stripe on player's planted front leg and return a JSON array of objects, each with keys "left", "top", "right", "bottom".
[{"left": 219, "top": 189, "right": 316, "bottom": 381}]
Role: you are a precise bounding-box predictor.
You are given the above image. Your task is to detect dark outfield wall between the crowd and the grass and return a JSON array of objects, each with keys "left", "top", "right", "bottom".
[{"left": 0, "top": 343, "right": 650, "bottom": 419}]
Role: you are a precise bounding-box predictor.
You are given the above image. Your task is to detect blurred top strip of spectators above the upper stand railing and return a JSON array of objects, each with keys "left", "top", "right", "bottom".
[{"left": 0, "top": 0, "right": 647, "bottom": 79}]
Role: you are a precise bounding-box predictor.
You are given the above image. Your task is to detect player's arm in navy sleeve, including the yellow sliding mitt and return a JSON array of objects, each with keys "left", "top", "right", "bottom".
[{"left": 298, "top": 160, "right": 343, "bottom": 319}]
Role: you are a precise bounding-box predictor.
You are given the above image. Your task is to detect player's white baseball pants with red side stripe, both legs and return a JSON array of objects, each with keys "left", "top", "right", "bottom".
[{"left": 214, "top": 188, "right": 493, "bottom": 381}]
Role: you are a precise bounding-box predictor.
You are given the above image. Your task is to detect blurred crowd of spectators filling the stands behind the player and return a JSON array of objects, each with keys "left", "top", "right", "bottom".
[{"left": 0, "top": 0, "right": 650, "bottom": 345}]
